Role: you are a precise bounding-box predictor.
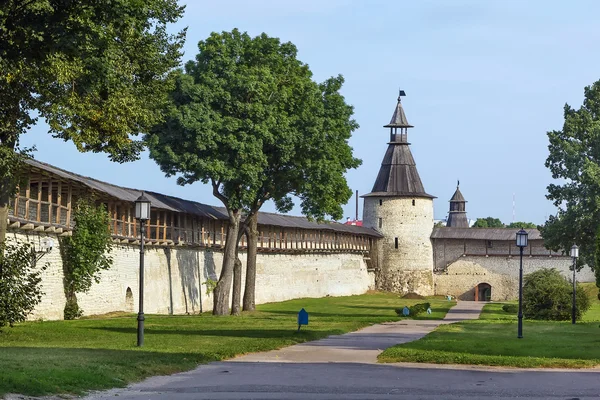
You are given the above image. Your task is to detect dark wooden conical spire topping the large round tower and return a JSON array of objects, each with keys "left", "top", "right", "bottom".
[{"left": 362, "top": 90, "right": 435, "bottom": 199}]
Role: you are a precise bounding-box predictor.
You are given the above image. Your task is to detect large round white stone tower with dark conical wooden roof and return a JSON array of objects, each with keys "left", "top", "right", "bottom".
[{"left": 362, "top": 90, "right": 435, "bottom": 295}]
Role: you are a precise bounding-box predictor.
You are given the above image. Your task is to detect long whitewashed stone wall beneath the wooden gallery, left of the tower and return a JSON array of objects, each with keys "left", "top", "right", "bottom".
[{"left": 8, "top": 232, "right": 372, "bottom": 320}]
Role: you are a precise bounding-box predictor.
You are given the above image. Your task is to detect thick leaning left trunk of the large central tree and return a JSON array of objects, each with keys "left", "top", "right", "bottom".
[{"left": 213, "top": 210, "right": 241, "bottom": 315}]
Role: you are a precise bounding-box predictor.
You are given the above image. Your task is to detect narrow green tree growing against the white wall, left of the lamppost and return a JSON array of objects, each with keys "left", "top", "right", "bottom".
[{"left": 60, "top": 198, "right": 112, "bottom": 319}]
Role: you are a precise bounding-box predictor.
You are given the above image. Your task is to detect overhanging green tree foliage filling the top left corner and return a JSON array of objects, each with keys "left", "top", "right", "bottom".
[{"left": 0, "top": 0, "right": 185, "bottom": 242}]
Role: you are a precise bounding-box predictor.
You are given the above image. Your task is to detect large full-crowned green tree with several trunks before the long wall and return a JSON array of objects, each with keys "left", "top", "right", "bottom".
[{"left": 146, "top": 30, "right": 360, "bottom": 315}]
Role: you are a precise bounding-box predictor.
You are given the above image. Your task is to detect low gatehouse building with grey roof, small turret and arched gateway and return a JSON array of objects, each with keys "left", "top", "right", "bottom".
[{"left": 431, "top": 186, "right": 594, "bottom": 301}]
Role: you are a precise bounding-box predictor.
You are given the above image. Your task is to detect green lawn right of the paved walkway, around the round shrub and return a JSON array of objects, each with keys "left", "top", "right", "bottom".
[{"left": 379, "top": 284, "right": 600, "bottom": 368}]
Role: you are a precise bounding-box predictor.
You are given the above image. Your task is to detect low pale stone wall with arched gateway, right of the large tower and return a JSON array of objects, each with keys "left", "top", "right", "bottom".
[{"left": 435, "top": 255, "right": 595, "bottom": 301}]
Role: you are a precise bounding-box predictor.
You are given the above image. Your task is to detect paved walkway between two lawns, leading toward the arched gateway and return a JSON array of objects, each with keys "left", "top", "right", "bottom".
[{"left": 229, "top": 301, "right": 485, "bottom": 364}]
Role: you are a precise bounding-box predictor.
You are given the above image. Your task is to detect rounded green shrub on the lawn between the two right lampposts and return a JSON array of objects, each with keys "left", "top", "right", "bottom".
[{"left": 523, "top": 268, "right": 590, "bottom": 321}]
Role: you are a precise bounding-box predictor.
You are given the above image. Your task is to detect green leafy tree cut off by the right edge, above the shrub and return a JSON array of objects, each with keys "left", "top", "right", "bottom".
[{"left": 541, "top": 81, "right": 600, "bottom": 268}]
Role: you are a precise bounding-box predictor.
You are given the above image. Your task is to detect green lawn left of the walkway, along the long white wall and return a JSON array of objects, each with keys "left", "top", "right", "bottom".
[{"left": 0, "top": 293, "right": 454, "bottom": 397}]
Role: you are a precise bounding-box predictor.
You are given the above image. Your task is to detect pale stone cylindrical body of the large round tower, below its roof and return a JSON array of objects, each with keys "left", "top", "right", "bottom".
[{"left": 363, "top": 197, "right": 433, "bottom": 295}]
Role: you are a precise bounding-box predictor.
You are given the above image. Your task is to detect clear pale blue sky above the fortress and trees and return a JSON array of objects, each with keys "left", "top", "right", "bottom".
[{"left": 21, "top": 0, "right": 600, "bottom": 223}]
